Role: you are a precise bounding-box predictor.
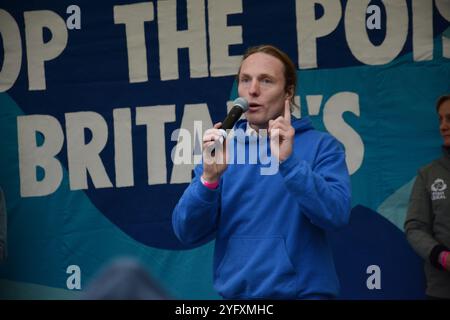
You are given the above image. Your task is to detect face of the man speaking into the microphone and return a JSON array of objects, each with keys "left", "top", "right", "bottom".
[{"left": 238, "top": 52, "right": 290, "bottom": 129}]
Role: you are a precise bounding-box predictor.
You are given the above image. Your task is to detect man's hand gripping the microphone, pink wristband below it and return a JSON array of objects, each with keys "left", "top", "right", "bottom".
[{"left": 202, "top": 122, "right": 227, "bottom": 182}]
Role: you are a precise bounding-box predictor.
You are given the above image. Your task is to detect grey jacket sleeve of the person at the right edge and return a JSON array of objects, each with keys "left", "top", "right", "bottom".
[{"left": 404, "top": 172, "right": 446, "bottom": 268}]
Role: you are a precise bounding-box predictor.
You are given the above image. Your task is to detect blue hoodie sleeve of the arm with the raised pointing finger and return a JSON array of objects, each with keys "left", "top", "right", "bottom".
[{"left": 280, "top": 135, "right": 351, "bottom": 230}]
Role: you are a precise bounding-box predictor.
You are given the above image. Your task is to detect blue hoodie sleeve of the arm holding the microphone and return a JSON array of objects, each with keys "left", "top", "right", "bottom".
[{"left": 172, "top": 165, "right": 222, "bottom": 246}]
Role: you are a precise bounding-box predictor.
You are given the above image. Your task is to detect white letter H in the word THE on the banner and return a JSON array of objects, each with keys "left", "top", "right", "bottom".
[{"left": 158, "top": 0, "right": 208, "bottom": 80}]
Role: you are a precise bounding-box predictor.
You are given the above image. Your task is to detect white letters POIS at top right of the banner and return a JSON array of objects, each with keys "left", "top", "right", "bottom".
[{"left": 295, "top": 0, "right": 450, "bottom": 69}]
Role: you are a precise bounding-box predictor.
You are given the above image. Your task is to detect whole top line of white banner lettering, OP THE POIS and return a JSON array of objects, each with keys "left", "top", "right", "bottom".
[{"left": 0, "top": 0, "right": 450, "bottom": 92}]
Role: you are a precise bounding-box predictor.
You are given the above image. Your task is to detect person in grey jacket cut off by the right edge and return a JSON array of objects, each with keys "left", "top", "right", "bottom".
[{"left": 405, "top": 95, "right": 450, "bottom": 299}]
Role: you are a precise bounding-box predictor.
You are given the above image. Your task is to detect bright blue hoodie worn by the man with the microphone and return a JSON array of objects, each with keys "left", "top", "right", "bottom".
[{"left": 172, "top": 118, "right": 351, "bottom": 299}]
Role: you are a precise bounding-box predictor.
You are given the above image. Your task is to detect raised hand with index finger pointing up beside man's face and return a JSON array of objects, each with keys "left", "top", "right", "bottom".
[{"left": 269, "top": 100, "right": 295, "bottom": 161}]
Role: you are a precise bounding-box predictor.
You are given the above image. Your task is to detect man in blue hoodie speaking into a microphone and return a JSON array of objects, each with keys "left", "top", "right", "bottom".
[{"left": 172, "top": 45, "right": 351, "bottom": 299}]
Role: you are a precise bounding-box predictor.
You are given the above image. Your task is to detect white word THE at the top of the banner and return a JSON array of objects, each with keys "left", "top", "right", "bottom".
[{"left": 114, "top": 0, "right": 242, "bottom": 83}]
